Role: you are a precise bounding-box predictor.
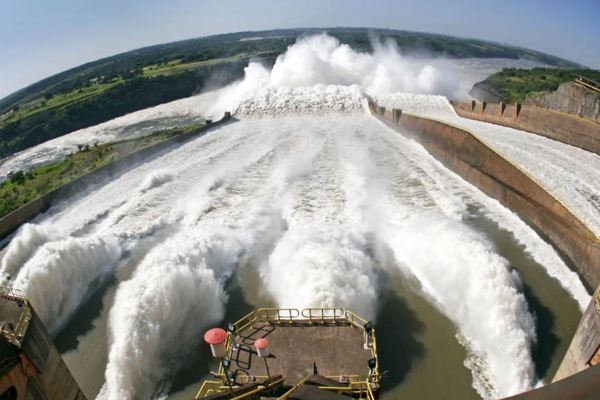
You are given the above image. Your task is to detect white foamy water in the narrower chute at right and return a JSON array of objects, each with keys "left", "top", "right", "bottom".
[{"left": 376, "top": 94, "right": 600, "bottom": 236}]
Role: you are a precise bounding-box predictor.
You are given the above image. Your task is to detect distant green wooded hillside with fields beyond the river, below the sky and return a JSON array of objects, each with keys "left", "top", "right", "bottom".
[{"left": 0, "top": 28, "right": 574, "bottom": 158}]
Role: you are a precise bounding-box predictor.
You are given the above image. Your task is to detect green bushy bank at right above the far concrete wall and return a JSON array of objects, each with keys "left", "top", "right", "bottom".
[{"left": 478, "top": 68, "right": 600, "bottom": 103}]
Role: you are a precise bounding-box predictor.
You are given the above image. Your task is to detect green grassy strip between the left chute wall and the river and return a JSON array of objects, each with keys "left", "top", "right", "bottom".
[{"left": 0, "top": 123, "right": 204, "bottom": 217}]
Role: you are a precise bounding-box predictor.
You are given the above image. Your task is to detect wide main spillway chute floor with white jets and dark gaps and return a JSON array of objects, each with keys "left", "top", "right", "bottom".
[{"left": 2, "top": 101, "right": 589, "bottom": 399}]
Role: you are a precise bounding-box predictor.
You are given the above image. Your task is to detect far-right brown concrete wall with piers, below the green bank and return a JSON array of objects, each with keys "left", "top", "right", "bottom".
[{"left": 452, "top": 101, "right": 600, "bottom": 154}]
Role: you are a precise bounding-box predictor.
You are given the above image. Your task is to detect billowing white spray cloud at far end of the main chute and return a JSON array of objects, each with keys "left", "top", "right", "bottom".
[{"left": 206, "top": 33, "right": 458, "bottom": 116}]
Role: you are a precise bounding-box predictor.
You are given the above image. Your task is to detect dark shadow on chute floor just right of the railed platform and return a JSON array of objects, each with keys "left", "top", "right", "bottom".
[{"left": 375, "top": 289, "right": 425, "bottom": 393}]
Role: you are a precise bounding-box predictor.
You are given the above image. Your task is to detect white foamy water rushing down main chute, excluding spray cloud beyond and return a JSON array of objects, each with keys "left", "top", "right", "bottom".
[{"left": 3, "top": 110, "right": 564, "bottom": 399}]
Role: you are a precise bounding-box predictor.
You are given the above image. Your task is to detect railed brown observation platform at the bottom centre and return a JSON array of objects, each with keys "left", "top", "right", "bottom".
[{"left": 196, "top": 308, "right": 380, "bottom": 399}]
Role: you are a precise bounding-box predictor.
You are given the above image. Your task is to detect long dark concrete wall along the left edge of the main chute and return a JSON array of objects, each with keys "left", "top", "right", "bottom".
[{"left": 0, "top": 113, "right": 231, "bottom": 239}]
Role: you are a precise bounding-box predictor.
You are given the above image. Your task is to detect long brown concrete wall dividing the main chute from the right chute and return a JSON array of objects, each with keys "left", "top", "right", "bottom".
[{"left": 370, "top": 104, "right": 600, "bottom": 291}]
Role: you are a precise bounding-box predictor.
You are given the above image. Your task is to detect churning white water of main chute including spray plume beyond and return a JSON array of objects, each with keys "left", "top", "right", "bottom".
[{"left": 0, "top": 33, "right": 589, "bottom": 400}]
